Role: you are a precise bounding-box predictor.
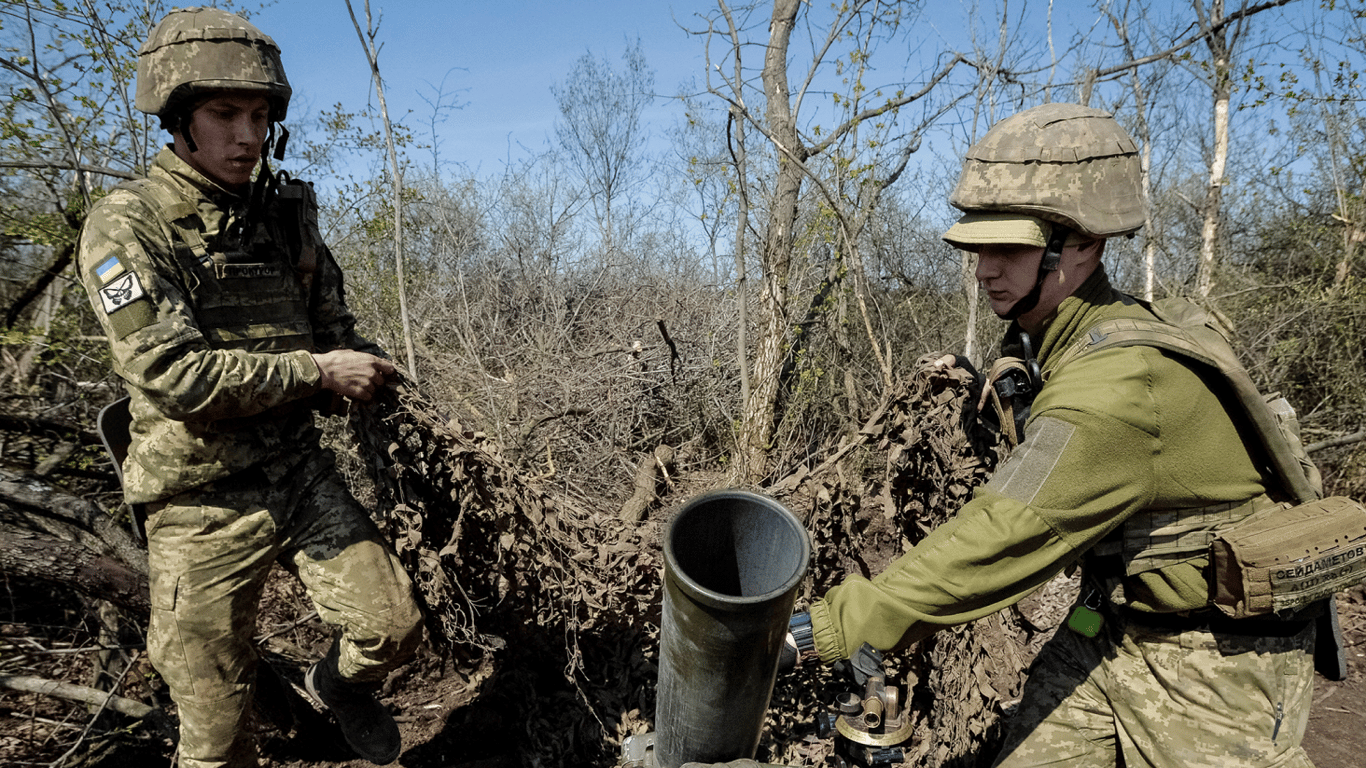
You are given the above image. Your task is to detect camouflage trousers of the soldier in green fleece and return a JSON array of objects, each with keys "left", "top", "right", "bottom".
[{"left": 996, "top": 606, "right": 1314, "bottom": 768}]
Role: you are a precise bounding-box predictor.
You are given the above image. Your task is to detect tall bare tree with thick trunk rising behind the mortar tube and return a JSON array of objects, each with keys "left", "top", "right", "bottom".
[{"left": 701, "top": 0, "right": 962, "bottom": 480}]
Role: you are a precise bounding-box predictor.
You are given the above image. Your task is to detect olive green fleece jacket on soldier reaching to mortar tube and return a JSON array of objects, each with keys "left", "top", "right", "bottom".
[{"left": 810, "top": 269, "right": 1266, "bottom": 661}]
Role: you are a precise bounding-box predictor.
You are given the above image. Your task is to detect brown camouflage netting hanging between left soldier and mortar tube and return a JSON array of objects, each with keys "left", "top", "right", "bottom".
[{"left": 344, "top": 384, "right": 660, "bottom": 765}]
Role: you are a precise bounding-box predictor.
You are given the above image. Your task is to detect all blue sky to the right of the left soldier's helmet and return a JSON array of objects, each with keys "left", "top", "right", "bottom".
[{"left": 237, "top": 0, "right": 1321, "bottom": 185}]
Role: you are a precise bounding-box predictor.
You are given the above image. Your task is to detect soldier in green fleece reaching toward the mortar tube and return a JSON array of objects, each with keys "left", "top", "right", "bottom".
[{"left": 790, "top": 104, "right": 1315, "bottom": 768}]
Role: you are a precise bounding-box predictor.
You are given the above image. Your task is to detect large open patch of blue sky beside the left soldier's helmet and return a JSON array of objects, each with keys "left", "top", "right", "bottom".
[{"left": 253, "top": 0, "right": 712, "bottom": 175}]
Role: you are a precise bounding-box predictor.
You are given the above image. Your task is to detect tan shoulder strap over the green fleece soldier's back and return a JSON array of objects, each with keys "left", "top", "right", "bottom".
[{"left": 1050, "top": 299, "right": 1321, "bottom": 503}]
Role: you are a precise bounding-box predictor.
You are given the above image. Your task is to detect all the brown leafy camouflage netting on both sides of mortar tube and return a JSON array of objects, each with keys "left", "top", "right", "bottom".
[{"left": 344, "top": 357, "right": 1065, "bottom": 767}]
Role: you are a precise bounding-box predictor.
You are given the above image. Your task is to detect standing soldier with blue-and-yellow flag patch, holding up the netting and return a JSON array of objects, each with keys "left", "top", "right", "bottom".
[{"left": 79, "top": 8, "right": 422, "bottom": 768}]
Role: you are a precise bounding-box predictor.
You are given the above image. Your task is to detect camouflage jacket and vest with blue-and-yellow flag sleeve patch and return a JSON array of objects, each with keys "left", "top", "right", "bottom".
[{"left": 78, "top": 149, "right": 380, "bottom": 503}]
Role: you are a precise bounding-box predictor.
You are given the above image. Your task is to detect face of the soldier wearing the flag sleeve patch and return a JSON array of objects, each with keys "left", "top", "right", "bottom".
[{"left": 175, "top": 92, "right": 270, "bottom": 191}]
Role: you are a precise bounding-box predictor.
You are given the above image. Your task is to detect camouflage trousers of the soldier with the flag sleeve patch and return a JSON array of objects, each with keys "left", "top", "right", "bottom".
[{"left": 146, "top": 450, "right": 422, "bottom": 768}]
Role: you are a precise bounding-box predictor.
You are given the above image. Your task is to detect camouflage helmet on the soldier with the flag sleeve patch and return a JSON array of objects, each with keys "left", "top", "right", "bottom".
[{"left": 134, "top": 7, "right": 292, "bottom": 122}]
